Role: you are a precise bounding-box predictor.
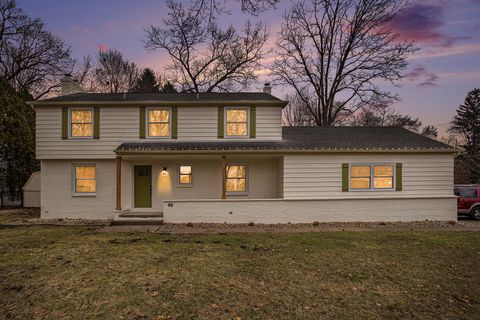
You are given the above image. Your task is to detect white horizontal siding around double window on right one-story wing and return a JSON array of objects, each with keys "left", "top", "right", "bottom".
[{"left": 284, "top": 153, "right": 453, "bottom": 199}]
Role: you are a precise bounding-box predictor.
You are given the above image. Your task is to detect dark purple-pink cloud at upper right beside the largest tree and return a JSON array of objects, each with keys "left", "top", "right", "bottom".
[{"left": 388, "top": 3, "right": 455, "bottom": 47}]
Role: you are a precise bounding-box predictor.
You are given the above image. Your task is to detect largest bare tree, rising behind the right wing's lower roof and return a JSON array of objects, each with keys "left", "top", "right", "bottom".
[{"left": 271, "top": 0, "right": 416, "bottom": 126}]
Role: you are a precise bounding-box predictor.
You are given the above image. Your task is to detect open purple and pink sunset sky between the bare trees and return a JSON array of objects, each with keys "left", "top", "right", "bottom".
[{"left": 17, "top": 0, "right": 480, "bottom": 135}]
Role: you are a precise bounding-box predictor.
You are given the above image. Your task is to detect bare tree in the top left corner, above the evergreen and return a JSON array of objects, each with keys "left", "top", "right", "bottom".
[{"left": 0, "top": 0, "right": 75, "bottom": 99}]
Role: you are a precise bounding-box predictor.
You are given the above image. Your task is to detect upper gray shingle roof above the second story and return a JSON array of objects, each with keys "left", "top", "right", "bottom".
[{"left": 38, "top": 92, "right": 282, "bottom": 103}]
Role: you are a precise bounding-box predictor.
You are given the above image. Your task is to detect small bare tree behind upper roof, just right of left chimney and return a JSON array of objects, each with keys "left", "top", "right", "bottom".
[{"left": 93, "top": 49, "right": 140, "bottom": 93}]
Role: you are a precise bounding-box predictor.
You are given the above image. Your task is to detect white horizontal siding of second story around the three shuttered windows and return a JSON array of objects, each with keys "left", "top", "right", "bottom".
[{"left": 36, "top": 106, "right": 282, "bottom": 159}]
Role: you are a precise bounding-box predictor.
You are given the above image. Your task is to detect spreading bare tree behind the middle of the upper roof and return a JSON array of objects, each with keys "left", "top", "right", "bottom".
[{"left": 144, "top": 1, "right": 268, "bottom": 92}]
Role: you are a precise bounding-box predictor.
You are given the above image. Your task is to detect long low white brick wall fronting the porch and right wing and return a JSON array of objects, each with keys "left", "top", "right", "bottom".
[{"left": 164, "top": 197, "right": 457, "bottom": 224}]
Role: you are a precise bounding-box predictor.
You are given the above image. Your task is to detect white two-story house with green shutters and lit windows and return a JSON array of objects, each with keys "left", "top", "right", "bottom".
[{"left": 33, "top": 78, "right": 456, "bottom": 223}]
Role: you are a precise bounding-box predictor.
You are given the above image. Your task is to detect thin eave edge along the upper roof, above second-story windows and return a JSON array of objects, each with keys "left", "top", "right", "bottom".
[{"left": 27, "top": 100, "right": 288, "bottom": 108}]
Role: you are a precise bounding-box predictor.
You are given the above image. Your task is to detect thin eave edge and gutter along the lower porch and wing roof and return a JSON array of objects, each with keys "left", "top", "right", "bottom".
[{"left": 114, "top": 148, "right": 458, "bottom": 155}]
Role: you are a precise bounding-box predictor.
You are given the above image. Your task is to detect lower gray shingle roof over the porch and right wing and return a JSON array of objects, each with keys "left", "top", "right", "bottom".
[{"left": 115, "top": 127, "right": 455, "bottom": 153}]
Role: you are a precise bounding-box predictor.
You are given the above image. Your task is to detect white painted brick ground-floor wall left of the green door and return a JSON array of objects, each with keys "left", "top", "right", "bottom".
[{"left": 40, "top": 160, "right": 115, "bottom": 219}]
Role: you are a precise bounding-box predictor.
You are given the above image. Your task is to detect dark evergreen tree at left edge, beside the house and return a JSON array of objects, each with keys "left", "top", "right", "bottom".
[{"left": 0, "top": 78, "right": 39, "bottom": 198}]
